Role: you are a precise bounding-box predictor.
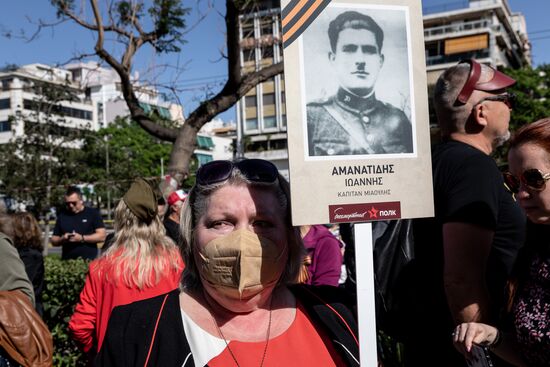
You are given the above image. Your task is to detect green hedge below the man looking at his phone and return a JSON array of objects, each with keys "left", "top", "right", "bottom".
[{"left": 42, "top": 256, "right": 89, "bottom": 367}]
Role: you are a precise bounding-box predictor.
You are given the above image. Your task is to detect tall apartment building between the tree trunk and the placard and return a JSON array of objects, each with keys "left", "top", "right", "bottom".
[{"left": 236, "top": 1, "right": 288, "bottom": 175}]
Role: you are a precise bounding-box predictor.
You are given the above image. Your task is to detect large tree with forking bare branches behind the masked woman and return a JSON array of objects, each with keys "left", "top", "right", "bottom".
[{"left": 50, "top": 0, "right": 283, "bottom": 182}]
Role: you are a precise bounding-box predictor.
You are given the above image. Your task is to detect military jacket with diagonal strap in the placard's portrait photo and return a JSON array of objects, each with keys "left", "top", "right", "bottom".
[{"left": 307, "top": 89, "right": 413, "bottom": 156}]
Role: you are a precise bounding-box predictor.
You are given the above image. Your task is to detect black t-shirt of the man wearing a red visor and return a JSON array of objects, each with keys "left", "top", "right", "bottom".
[{"left": 411, "top": 141, "right": 525, "bottom": 360}]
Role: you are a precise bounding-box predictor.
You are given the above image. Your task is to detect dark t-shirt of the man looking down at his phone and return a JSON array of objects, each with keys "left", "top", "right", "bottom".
[{"left": 53, "top": 207, "right": 105, "bottom": 259}]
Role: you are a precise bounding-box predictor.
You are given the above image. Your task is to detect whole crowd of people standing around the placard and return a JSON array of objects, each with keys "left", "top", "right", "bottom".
[{"left": 0, "top": 60, "right": 550, "bottom": 367}]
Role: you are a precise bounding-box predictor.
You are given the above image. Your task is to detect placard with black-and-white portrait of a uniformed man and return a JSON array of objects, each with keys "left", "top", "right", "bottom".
[{"left": 282, "top": 0, "right": 433, "bottom": 225}]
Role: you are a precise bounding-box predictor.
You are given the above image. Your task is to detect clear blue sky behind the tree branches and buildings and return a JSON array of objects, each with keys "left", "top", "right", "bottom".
[{"left": 0, "top": 0, "right": 550, "bottom": 121}]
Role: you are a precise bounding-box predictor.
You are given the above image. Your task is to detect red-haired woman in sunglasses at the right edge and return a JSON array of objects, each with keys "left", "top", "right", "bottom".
[{"left": 454, "top": 118, "right": 550, "bottom": 367}]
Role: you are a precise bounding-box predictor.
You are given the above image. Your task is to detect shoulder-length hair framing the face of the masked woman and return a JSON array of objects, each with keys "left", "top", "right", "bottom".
[{"left": 180, "top": 167, "right": 305, "bottom": 289}]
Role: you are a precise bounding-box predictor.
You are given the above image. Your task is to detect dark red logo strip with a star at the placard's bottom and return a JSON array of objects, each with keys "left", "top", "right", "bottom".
[{"left": 328, "top": 201, "right": 401, "bottom": 223}]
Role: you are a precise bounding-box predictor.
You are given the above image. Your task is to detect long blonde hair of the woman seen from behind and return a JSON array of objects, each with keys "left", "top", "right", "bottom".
[{"left": 98, "top": 200, "right": 181, "bottom": 289}]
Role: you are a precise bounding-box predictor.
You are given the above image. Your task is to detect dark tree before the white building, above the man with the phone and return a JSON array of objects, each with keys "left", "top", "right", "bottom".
[{"left": 0, "top": 81, "right": 86, "bottom": 216}]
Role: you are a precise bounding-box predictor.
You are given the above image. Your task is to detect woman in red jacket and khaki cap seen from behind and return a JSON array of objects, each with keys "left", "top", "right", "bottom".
[{"left": 69, "top": 179, "right": 183, "bottom": 356}]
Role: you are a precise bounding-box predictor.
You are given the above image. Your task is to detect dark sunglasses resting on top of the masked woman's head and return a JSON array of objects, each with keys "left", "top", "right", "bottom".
[{"left": 197, "top": 159, "right": 279, "bottom": 185}]
